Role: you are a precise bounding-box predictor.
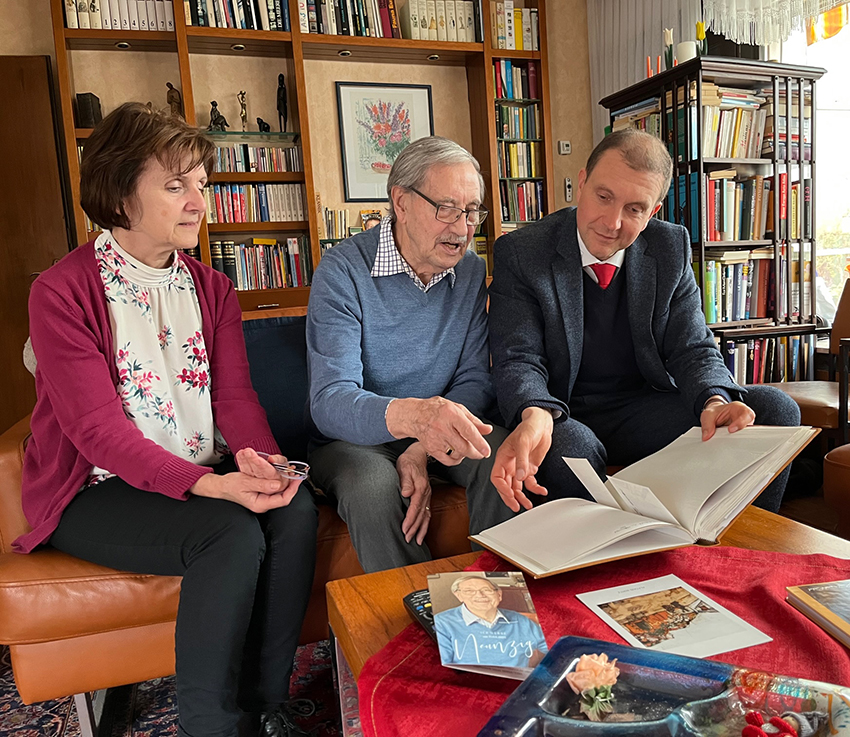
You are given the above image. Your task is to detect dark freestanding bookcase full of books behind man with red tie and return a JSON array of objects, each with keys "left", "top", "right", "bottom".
[{"left": 600, "top": 57, "right": 825, "bottom": 383}]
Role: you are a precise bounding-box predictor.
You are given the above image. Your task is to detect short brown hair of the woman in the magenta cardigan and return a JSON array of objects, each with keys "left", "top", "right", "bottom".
[{"left": 80, "top": 102, "right": 215, "bottom": 230}]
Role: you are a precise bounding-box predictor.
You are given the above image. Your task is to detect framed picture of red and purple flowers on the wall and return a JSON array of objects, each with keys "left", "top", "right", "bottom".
[{"left": 336, "top": 82, "right": 434, "bottom": 202}]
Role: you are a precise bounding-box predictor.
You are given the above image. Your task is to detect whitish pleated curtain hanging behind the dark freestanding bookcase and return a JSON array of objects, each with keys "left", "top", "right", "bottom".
[{"left": 587, "top": 0, "right": 704, "bottom": 144}]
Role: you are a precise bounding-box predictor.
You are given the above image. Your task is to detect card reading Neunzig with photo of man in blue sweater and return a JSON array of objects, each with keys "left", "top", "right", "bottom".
[{"left": 428, "top": 571, "right": 549, "bottom": 680}]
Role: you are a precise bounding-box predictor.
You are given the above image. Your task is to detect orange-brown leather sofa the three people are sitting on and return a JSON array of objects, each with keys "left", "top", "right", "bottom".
[{"left": 0, "top": 418, "right": 470, "bottom": 707}]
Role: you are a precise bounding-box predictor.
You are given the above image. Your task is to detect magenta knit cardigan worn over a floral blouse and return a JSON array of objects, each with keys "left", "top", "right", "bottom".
[{"left": 12, "top": 242, "right": 280, "bottom": 553}]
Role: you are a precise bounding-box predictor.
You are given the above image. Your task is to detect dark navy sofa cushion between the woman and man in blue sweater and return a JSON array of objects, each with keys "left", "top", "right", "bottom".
[{"left": 242, "top": 316, "right": 308, "bottom": 461}]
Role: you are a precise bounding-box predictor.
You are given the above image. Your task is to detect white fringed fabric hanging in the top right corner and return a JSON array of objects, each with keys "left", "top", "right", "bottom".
[{"left": 703, "top": 0, "right": 847, "bottom": 46}]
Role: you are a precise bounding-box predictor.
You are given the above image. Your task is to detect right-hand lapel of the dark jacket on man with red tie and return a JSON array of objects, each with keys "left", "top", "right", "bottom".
[{"left": 624, "top": 235, "right": 658, "bottom": 376}]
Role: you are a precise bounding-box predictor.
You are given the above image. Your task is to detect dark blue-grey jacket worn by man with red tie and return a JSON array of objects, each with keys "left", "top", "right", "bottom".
[{"left": 490, "top": 208, "right": 745, "bottom": 427}]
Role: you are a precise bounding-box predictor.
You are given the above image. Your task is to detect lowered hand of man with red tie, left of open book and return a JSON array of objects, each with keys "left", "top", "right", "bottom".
[{"left": 490, "top": 407, "right": 554, "bottom": 512}]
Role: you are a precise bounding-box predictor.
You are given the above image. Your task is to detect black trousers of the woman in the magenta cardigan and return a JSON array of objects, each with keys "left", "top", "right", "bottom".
[{"left": 50, "top": 461, "right": 317, "bottom": 737}]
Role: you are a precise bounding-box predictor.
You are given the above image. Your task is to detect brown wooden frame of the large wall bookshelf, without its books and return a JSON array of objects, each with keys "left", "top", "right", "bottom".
[{"left": 50, "top": 0, "right": 554, "bottom": 317}]
